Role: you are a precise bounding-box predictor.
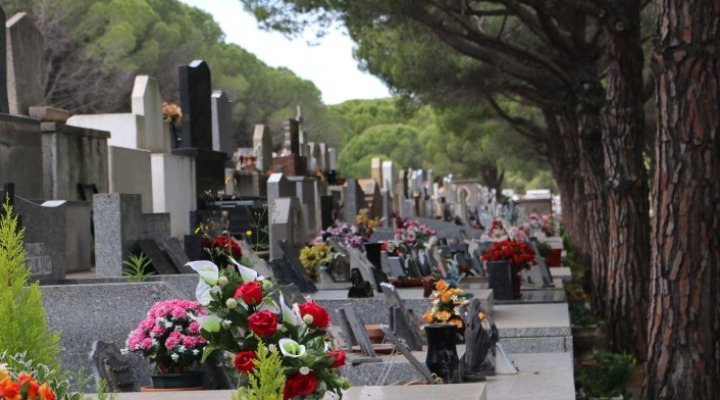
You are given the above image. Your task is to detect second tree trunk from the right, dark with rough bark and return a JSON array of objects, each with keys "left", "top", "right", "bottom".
[{"left": 602, "top": 0, "right": 650, "bottom": 360}]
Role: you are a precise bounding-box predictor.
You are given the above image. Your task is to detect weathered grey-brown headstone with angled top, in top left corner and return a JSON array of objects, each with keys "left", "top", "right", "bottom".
[{"left": 3, "top": 12, "right": 45, "bottom": 115}]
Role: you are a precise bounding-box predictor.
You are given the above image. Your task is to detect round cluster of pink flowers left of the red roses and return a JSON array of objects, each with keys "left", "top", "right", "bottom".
[{"left": 126, "top": 300, "right": 207, "bottom": 374}]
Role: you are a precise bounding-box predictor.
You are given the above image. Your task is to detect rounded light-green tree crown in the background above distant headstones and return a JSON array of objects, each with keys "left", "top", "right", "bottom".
[{"left": 338, "top": 124, "right": 424, "bottom": 178}]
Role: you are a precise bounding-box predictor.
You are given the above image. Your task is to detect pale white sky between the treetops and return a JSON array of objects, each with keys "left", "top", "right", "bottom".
[{"left": 180, "top": 0, "right": 390, "bottom": 105}]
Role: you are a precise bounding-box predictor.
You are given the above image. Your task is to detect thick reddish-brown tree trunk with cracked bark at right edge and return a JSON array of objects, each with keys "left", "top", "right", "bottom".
[{"left": 643, "top": 0, "right": 720, "bottom": 400}]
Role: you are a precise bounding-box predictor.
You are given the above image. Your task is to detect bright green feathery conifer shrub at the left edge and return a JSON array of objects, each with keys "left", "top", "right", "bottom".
[{"left": 0, "top": 201, "right": 60, "bottom": 371}]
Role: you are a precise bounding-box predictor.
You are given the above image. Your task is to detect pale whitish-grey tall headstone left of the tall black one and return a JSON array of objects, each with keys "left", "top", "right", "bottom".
[{"left": 132, "top": 75, "right": 170, "bottom": 154}]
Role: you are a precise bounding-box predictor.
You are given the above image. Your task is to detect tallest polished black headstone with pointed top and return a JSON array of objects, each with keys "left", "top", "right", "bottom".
[{"left": 176, "top": 60, "right": 213, "bottom": 150}]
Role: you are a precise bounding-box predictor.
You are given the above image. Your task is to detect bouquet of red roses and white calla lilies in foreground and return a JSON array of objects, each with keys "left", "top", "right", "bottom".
[{"left": 187, "top": 259, "right": 349, "bottom": 399}]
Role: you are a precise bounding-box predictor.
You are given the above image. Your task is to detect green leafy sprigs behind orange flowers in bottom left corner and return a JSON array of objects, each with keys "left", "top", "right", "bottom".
[{"left": 0, "top": 351, "right": 83, "bottom": 400}]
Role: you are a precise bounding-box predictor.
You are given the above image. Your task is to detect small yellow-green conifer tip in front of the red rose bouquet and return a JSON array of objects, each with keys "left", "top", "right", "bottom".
[{"left": 232, "top": 342, "right": 285, "bottom": 400}]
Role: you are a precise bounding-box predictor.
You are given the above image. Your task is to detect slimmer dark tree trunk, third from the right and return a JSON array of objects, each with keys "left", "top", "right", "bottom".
[{"left": 577, "top": 74, "right": 608, "bottom": 315}]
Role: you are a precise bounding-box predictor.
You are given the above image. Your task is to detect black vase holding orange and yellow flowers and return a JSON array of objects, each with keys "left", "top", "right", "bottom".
[{"left": 425, "top": 324, "right": 460, "bottom": 383}]
